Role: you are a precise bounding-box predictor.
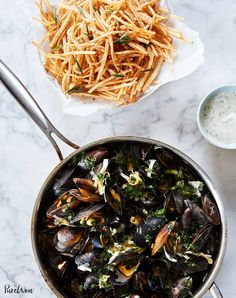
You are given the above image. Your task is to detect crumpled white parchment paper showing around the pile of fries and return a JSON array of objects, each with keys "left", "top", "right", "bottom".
[{"left": 34, "top": 1, "right": 204, "bottom": 116}]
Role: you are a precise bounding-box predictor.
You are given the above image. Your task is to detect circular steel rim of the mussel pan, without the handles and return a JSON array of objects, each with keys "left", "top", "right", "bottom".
[{"left": 31, "top": 136, "right": 227, "bottom": 298}]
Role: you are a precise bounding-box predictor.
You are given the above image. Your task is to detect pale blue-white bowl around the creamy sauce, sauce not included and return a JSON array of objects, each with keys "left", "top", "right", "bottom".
[{"left": 197, "top": 85, "right": 236, "bottom": 149}]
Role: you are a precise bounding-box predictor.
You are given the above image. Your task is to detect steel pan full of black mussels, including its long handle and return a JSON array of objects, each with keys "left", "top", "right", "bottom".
[{"left": 0, "top": 59, "right": 227, "bottom": 298}]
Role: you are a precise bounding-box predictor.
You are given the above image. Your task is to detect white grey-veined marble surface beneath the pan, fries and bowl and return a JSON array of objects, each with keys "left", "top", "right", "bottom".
[{"left": 0, "top": 0, "right": 236, "bottom": 298}]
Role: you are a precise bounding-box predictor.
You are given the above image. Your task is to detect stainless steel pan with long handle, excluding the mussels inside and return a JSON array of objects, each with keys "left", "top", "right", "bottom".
[{"left": 0, "top": 60, "right": 227, "bottom": 298}]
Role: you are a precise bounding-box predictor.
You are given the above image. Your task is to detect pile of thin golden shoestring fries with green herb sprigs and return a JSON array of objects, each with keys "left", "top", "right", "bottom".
[{"left": 34, "top": 0, "right": 184, "bottom": 105}]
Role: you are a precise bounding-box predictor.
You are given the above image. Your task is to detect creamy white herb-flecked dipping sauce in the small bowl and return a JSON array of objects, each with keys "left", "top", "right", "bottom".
[{"left": 202, "top": 92, "right": 236, "bottom": 144}]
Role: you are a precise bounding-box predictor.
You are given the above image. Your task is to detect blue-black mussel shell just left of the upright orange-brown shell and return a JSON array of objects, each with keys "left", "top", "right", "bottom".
[{"left": 134, "top": 216, "right": 166, "bottom": 247}]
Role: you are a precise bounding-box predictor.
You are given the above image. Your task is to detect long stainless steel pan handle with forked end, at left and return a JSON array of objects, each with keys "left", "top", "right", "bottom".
[{"left": 0, "top": 60, "right": 79, "bottom": 160}]
